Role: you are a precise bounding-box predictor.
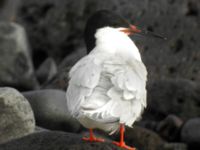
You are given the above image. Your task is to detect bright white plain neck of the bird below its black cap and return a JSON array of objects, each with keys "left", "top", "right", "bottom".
[{"left": 94, "top": 27, "right": 141, "bottom": 61}]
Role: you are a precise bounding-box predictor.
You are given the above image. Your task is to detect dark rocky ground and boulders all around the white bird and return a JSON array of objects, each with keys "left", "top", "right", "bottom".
[{"left": 0, "top": 0, "right": 200, "bottom": 150}]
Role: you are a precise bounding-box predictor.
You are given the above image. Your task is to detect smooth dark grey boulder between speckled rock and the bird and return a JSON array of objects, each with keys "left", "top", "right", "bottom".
[{"left": 23, "top": 89, "right": 80, "bottom": 132}]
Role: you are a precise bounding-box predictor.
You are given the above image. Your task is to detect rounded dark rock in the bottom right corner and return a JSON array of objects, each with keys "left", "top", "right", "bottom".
[{"left": 181, "top": 118, "right": 200, "bottom": 150}]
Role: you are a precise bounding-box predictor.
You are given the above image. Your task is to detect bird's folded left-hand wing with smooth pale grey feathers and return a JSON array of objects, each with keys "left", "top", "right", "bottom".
[{"left": 66, "top": 55, "right": 101, "bottom": 116}]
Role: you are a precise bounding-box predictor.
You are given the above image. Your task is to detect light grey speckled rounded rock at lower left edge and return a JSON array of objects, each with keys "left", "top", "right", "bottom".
[{"left": 0, "top": 87, "right": 35, "bottom": 143}]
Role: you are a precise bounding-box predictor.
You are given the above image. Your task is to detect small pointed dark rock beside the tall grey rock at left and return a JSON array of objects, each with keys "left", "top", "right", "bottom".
[{"left": 36, "top": 58, "right": 58, "bottom": 84}]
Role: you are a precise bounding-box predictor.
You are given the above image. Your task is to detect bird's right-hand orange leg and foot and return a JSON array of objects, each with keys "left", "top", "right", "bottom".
[{"left": 113, "top": 124, "right": 135, "bottom": 150}]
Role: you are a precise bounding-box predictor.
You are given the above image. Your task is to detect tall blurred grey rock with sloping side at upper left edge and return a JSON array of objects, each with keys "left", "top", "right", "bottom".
[{"left": 0, "top": 22, "right": 38, "bottom": 90}]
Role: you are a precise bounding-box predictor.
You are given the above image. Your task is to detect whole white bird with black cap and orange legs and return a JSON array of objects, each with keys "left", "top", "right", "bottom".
[{"left": 66, "top": 10, "right": 163, "bottom": 150}]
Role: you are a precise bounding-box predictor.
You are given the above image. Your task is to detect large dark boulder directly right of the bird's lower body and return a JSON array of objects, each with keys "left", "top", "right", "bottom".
[{"left": 143, "top": 79, "right": 200, "bottom": 121}]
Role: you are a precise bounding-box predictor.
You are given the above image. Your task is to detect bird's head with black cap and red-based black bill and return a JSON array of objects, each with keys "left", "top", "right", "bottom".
[{"left": 84, "top": 10, "right": 166, "bottom": 53}]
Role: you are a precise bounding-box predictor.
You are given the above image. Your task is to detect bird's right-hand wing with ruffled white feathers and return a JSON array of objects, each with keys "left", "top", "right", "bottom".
[{"left": 101, "top": 59, "right": 147, "bottom": 126}]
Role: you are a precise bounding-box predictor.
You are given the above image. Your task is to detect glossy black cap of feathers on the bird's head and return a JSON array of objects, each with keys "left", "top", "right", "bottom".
[{"left": 84, "top": 10, "right": 129, "bottom": 53}]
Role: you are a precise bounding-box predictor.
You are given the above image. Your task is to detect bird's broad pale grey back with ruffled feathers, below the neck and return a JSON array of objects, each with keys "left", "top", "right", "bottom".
[{"left": 67, "top": 53, "right": 147, "bottom": 131}]
